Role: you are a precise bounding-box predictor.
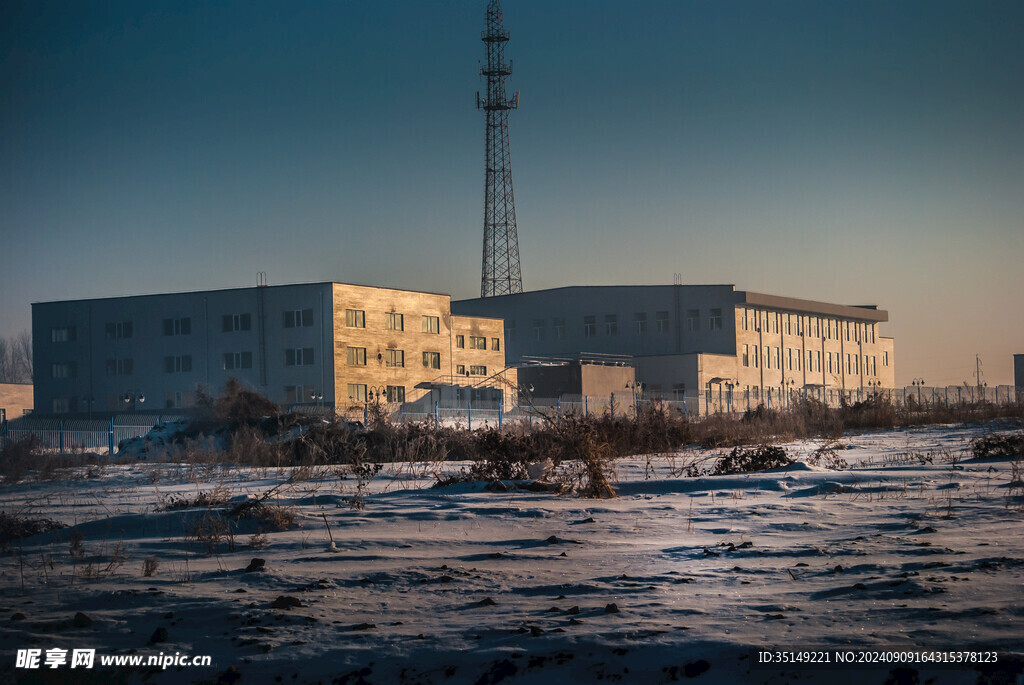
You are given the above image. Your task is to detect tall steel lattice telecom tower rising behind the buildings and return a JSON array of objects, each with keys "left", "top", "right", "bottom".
[{"left": 476, "top": 0, "right": 522, "bottom": 297}]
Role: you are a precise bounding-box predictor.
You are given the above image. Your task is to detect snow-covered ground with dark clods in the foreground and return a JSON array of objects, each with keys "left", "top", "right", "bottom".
[{"left": 0, "top": 419, "right": 1024, "bottom": 683}]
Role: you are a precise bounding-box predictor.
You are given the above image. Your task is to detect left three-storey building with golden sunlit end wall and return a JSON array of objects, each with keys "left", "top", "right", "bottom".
[{"left": 32, "top": 283, "right": 515, "bottom": 415}]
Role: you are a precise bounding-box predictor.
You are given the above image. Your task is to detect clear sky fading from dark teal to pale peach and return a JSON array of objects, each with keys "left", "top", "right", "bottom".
[{"left": 0, "top": 0, "right": 1024, "bottom": 385}]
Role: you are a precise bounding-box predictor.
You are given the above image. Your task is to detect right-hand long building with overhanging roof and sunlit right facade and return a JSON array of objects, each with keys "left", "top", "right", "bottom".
[{"left": 452, "top": 285, "right": 895, "bottom": 405}]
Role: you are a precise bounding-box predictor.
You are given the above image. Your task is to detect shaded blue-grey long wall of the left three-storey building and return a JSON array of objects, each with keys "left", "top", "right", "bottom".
[{"left": 33, "top": 284, "right": 333, "bottom": 414}]
